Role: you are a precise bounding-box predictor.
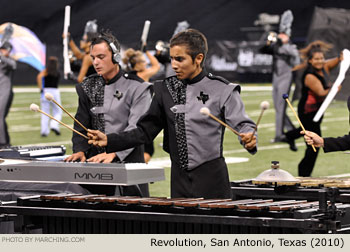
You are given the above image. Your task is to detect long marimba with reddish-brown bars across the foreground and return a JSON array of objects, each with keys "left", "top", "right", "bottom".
[{"left": 0, "top": 194, "right": 350, "bottom": 234}]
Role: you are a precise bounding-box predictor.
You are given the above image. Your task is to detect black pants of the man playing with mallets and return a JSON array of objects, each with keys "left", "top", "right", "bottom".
[{"left": 171, "top": 157, "right": 232, "bottom": 199}]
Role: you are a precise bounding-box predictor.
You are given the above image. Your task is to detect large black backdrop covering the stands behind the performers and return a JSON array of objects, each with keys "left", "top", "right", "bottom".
[{"left": 0, "top": 0, "right": 350, "bottom": 84}]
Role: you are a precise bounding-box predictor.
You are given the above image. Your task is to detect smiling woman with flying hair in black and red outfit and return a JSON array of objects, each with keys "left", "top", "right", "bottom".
[{"left": 286, "top": 41, "right": 343, "bottom": 177}]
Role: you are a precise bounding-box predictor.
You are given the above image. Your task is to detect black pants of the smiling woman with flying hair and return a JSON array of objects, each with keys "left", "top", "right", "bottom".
[{"left": 286, "top": 113, "right": 322, "bottom": 177}]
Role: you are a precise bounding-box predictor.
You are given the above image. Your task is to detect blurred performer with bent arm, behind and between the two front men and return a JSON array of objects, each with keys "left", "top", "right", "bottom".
[{"left": 123, "top": 46, "right": 160, "bottom": 163}]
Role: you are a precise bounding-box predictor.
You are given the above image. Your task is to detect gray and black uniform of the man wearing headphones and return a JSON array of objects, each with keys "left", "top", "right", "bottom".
[{"left": 72, "top": 70, "right": 151, "bottom": 196}]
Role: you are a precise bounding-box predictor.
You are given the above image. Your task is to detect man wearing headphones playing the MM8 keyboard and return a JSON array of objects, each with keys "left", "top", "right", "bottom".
[{"left": 65, "top": 32, "right": 151, "bottom": 196}]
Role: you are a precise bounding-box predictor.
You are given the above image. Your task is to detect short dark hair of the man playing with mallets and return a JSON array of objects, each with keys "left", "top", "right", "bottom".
[{"left": 170, "top": 29, "right": 208, "bottom": 67}]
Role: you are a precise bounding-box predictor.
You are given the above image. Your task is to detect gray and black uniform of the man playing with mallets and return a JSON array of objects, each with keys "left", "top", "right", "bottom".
[{"left": 106, "top": 71, "right": 256, "bottom": 198}]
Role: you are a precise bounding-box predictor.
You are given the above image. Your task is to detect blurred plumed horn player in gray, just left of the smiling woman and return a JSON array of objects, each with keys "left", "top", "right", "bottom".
[{"left": 261, "top": 10, "right": 300, "bottom": 151}]
